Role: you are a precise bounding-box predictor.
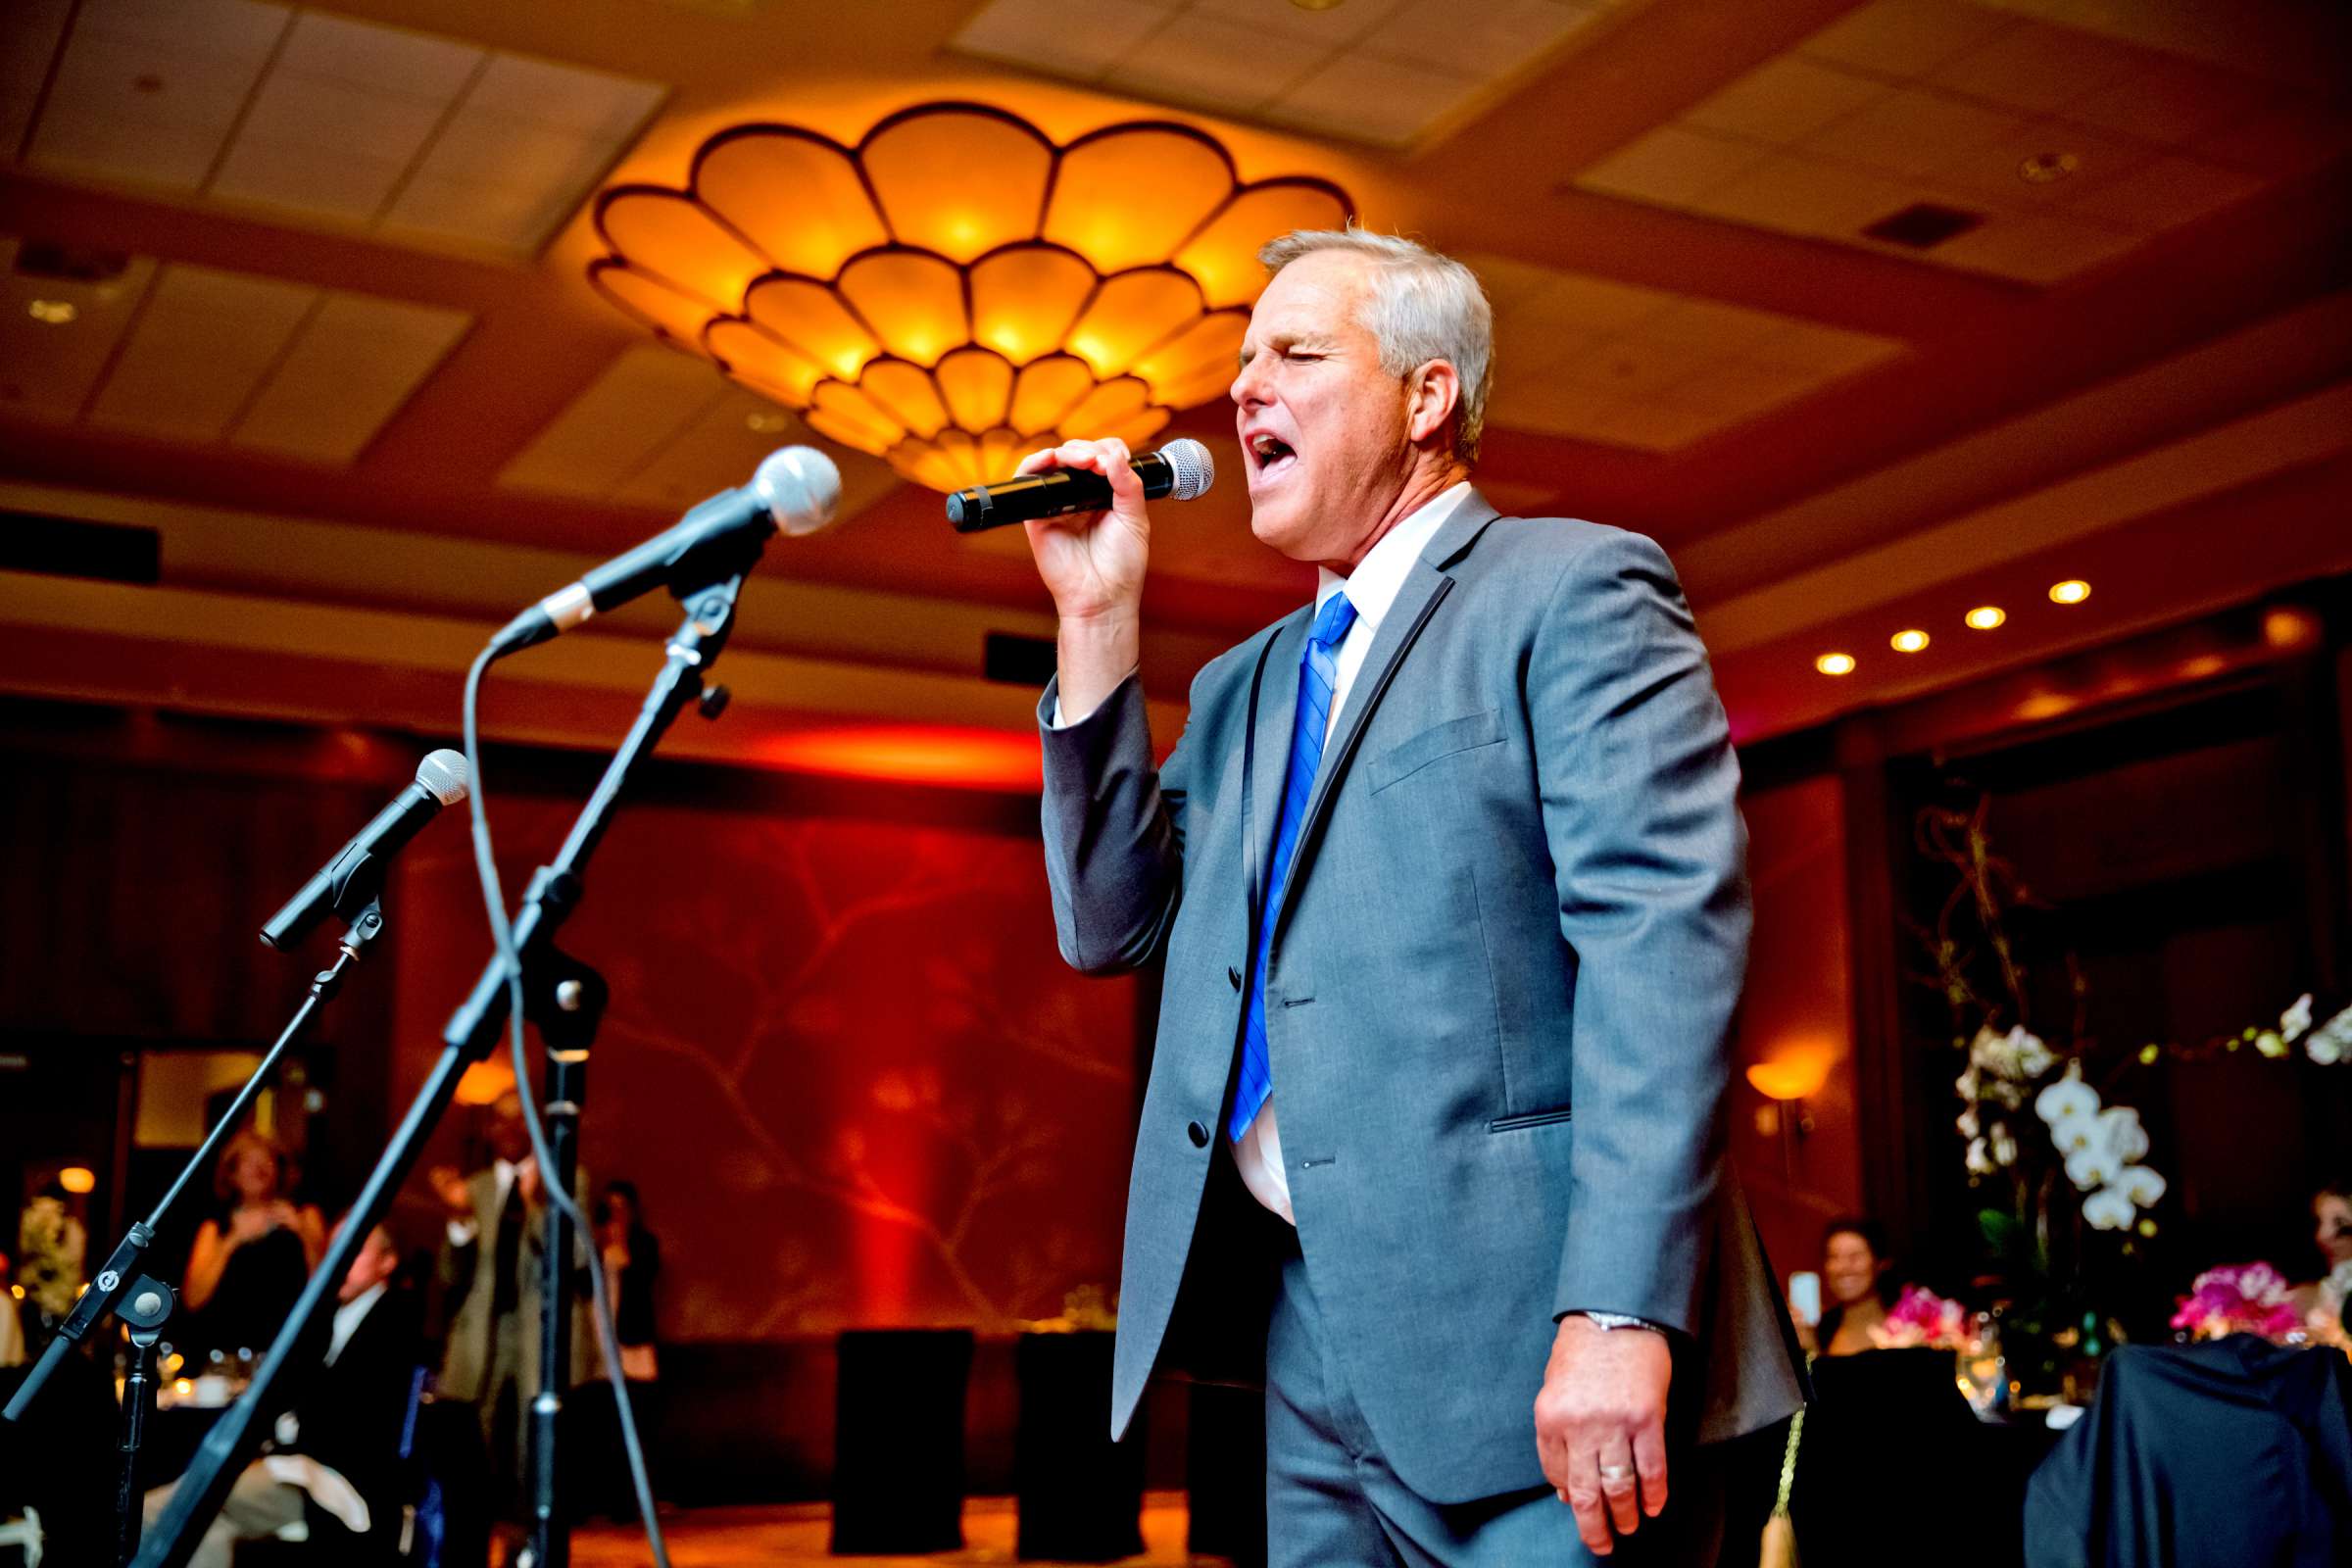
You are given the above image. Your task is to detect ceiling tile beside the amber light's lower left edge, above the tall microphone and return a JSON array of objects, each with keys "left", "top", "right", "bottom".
[{"left": 499, "top": 343, "right": 729, "bottom": 499}]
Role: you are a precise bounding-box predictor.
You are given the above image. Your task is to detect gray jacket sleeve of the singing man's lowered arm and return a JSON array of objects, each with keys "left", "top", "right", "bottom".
[{"left": 1527, "top": 531, "right": 1747, "bottom": 1333}]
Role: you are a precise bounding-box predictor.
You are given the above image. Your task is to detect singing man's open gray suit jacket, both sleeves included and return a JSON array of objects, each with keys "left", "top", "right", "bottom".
[{"left": 1040, "top": 494, "right": 1801, "bottom": 1502}]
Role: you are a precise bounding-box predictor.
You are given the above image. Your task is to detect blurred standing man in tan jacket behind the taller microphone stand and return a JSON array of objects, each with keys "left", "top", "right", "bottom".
[{"left": 430, "top": 1091, "right": 598, "bottom": 1514}]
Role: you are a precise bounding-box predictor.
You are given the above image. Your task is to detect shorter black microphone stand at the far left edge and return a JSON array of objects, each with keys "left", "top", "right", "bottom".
[{"left": 0, "top": 903, "right": 383, "bottom": 1563}]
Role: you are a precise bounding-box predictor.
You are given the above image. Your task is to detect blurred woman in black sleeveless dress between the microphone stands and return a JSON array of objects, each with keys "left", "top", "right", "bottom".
[{"left": 181, "top": 1133, "right": 327, "bottom": 1356}]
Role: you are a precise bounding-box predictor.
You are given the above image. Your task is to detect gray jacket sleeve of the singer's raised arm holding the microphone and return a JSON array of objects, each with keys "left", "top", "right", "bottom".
[{"left": 1037, "top": 674, "right": 1198, "bottom": 976}]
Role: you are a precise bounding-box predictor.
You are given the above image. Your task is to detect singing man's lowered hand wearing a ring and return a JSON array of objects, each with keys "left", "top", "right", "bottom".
[{"left": 1536, "top": 1314, "right": 1675, "bottom": 1556}]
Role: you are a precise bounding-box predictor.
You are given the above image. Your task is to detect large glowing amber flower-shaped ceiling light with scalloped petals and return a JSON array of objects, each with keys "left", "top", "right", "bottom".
[{"left": 588, "top": 104, "right": 1350, "bottom": 491}]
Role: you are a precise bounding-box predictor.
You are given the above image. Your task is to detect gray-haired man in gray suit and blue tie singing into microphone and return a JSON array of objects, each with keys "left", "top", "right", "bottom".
[{"left": 1023, "top": 230, "right": 1799, "bottom": 1568}]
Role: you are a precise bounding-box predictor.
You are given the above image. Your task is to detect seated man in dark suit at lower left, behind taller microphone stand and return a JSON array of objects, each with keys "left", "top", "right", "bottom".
[{"left": 146, "top": 1225, "right": 421, "bottom": 1568}]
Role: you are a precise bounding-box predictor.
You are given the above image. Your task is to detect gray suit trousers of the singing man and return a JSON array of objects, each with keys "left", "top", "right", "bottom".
[{"left": 1265, "top": 1227, "right": 1722, "bottom": 1568}]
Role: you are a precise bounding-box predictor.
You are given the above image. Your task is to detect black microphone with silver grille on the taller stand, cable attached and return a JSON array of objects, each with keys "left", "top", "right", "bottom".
[{"left": 489, "top": 447, "right": 842, "bottom": 659}]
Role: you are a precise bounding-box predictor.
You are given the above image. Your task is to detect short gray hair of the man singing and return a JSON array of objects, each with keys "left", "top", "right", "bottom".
[{"left": 1258, "top": 228, "right": 1494, "bottom": 464}]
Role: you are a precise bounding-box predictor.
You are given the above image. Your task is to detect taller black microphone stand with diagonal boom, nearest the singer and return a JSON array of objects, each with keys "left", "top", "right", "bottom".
[{"left": 136, "top": 566, "right": 748, "bottom": 1568}]
